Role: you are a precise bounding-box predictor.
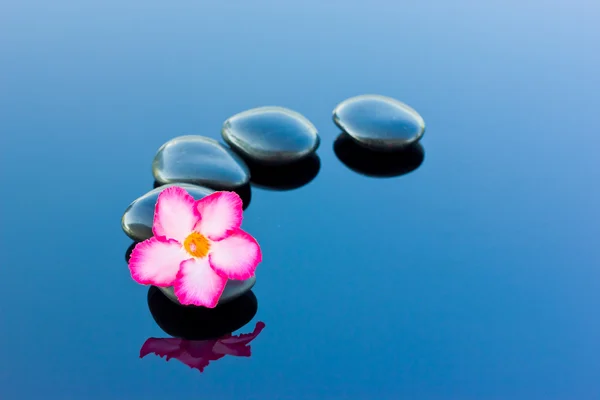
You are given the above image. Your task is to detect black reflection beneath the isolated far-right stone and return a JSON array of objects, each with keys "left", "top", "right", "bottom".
[{"left": 333, "top": 133, "right": 425, "bottom": 178}]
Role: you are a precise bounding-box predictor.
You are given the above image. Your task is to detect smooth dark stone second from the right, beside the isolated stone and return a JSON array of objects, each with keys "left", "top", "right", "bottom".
[{"left": 221, "top": 107, "right": 320, "bottom": 165}]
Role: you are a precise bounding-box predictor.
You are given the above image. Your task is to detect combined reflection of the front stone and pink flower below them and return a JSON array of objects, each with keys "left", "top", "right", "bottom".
[{"left": 140, "top": 286, "right": 265, "bottom": 372}]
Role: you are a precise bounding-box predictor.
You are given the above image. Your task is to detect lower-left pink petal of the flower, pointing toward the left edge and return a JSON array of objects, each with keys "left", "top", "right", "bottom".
[{"left": 129, "top": 237, "right": 189, "bottom": 287}]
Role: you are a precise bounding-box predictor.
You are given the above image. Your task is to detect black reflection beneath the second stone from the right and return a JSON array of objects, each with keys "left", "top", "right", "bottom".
[{"left": 246, "top": 154, "right": 321, "bottom": 190}]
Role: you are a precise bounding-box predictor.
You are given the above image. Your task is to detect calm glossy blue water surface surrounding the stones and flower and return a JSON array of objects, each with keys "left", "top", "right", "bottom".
[{"left": 0, "top": 0, "right": 600, "bottom": 400}]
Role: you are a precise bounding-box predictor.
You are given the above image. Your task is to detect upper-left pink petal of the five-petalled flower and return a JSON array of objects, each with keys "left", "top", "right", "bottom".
[{"left": 152, "top": 186, "right": 199, "bottom": 243}]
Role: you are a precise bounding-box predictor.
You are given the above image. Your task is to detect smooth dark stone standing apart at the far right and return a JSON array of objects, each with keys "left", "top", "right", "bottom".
[{"left": 333, "top": 95, "right": 425, "bottom": 151}]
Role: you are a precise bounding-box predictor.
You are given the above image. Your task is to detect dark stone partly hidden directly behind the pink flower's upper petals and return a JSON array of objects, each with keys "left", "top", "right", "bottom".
[{"left": 121, "top": 183, "right": 213, "bottom": 242}]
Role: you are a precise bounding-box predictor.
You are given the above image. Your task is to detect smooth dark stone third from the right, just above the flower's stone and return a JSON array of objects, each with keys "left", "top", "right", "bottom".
[{"left": 152, "top": 135, "right": 250, "bottom": 190}]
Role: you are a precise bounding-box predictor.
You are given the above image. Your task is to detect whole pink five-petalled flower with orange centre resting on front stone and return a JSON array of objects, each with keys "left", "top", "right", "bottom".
[{"left": 129, "top": 186, "right": 262, "bottom": 308}]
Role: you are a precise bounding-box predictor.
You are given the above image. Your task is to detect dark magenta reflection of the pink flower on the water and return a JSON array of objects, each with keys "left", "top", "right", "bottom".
[{"left": 140, "top": 322, "right": 265, "bottom": 372}]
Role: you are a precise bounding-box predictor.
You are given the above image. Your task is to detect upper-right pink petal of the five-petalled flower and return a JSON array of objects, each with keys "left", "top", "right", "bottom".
[{"left": 195, "top": 192, "right": 243, "bottom": 240}]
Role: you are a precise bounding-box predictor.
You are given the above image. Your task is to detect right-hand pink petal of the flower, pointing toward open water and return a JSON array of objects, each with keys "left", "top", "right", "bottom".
[{"left": 208, "top": 229, "right": 262, "bottom": 280}]
